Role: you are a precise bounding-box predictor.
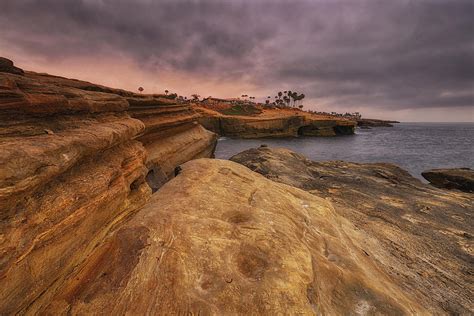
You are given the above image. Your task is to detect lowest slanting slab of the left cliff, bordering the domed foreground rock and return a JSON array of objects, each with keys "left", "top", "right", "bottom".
[{"left": 0, "top": 141, "right": 151, "bottom": 315}]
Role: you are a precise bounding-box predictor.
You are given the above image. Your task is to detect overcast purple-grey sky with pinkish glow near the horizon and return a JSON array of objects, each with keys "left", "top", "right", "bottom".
[{"left": 0, "top": 0, "right": 474, "bottom": 122}]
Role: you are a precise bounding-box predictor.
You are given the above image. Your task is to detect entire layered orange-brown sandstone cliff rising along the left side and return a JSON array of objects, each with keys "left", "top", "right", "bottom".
[{"left": 0, "top": 57, "right": 216, "bottom": 315}]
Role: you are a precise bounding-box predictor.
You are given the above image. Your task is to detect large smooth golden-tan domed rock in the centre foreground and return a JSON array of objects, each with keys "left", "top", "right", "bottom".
[{"left": 27, "top": 159, "right": 423, "bottom": 315}]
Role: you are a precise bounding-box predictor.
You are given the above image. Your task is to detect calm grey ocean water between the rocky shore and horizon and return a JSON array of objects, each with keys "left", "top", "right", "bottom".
[{"left": 216, "top": 123, "right": 474, "bottom": 180}]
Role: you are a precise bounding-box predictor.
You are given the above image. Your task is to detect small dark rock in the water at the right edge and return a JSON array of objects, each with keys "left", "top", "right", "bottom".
[{"left": 421, "top": 168, "right": 474, "bottom": 192}]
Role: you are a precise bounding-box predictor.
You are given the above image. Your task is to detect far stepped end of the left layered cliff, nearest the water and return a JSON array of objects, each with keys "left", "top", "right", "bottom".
[{"left": 128, "top": 97, "right": 217, "bottom": 190}]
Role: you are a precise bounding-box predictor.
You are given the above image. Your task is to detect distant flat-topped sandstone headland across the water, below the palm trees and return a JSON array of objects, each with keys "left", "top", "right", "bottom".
[{"left": 198, "top": 108, "right": 356, "bottom": 138}]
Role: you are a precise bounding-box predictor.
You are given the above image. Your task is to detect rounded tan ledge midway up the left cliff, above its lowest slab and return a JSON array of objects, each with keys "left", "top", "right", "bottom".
[{"left": 0, "top": 114, "right": 144, "bottom": 218}]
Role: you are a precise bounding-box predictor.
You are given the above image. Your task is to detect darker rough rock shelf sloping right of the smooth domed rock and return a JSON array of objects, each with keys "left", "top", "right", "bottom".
[{"left": 231, "top": 147, "right": 474, "bottom": 315}]
